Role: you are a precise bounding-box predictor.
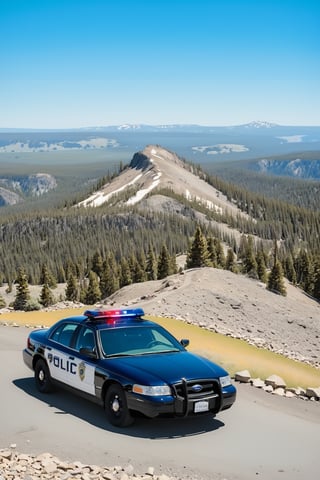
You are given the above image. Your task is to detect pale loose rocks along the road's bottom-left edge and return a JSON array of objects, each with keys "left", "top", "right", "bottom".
[{"left": 0, "top": 445, "right": 179, "bottom": 480}]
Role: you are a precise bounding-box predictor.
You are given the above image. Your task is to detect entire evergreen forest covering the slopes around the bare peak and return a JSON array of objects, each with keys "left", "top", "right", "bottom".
[{"left": 0, "top": 149, "right": 320, "bottom": 309}]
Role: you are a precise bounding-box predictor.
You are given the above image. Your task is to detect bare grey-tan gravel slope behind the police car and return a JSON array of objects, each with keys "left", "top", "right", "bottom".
[{"left": 108, "top": 268, "right": 320, "bottom": 365}]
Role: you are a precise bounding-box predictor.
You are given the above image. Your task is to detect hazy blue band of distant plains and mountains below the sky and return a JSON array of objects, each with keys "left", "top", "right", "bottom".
[{"left": 0, "top": 121, "right": 320, "bottom": 166}]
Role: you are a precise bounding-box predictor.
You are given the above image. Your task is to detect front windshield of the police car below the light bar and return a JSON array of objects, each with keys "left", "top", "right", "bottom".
[{"left": 99, "top": 326, "right": 183, "bottom": 357}]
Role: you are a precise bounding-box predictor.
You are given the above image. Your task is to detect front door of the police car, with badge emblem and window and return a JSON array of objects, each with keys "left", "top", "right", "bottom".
[{"left": 69, "top": 326, "right": 97, "bottom": 395}]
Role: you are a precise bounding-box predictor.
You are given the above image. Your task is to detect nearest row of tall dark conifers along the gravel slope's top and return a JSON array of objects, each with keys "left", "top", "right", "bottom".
[{"left": 6, "top": 225, "right": 320, "bottom": 310}]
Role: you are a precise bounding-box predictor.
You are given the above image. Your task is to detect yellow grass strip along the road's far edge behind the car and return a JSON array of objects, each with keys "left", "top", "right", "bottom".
[{"left": 0, "top": 307, "right": 320, "bottom": 388}]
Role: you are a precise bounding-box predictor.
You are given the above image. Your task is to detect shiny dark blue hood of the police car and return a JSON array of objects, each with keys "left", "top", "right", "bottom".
[{"left": 105, "top": 352, "right": 227, "bottom": 385}]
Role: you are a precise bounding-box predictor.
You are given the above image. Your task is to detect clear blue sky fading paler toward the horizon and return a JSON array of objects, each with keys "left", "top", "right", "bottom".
[{"left": 0, "top": 0, "right": 320, "bottom": 128}]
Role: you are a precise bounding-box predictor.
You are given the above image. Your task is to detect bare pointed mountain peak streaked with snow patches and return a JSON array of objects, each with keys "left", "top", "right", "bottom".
[{"left": 79, "top": 145, "right": 250, "bottom": 221}]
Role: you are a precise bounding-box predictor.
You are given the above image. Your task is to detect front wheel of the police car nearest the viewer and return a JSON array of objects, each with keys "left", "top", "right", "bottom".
[{"left": 105, "top": 384, "right": 133, "bottom": 427}]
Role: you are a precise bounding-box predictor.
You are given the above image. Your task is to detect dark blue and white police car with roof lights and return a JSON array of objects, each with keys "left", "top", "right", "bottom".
[{"left": 23, "top": 308, "right": 236, "bottom": 427}]
